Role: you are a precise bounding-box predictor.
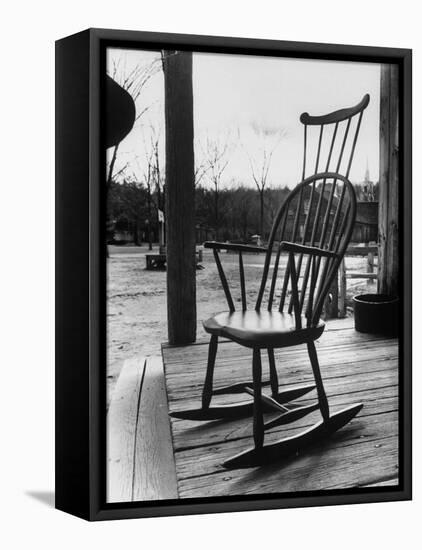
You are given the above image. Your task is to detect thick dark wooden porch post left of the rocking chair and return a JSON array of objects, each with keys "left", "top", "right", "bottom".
[{"left": 163, "top": 51, "right": 196, "bottom": 344}]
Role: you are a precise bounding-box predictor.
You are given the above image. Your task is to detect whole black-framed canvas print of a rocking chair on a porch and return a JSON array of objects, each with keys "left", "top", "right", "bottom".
[{"left": 56, "top": 29, "right": 411, "bottom": 520}]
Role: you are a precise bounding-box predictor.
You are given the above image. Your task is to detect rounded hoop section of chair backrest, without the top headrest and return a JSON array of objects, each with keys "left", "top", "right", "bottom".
[{"left": 255, "top": 172, "right": 356, "bottom": 328}]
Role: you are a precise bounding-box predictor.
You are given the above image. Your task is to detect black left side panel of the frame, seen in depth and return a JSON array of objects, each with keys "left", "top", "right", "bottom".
[{"left": 55, "top": 31, "right": 90, "bottom": 519}]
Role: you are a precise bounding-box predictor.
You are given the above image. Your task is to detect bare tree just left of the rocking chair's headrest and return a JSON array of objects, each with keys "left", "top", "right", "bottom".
[{"left": 243, "top": 122, "right": 285, "bottom": 238}]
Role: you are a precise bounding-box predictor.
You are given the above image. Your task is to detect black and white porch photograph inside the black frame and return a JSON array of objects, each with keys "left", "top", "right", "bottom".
[{"left": 103, "top": 46, "right": 404, "bottom": 504}]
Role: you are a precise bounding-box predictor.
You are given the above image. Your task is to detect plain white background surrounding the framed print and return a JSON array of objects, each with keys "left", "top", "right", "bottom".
[{"left": 0, "top": 0, "right": 422, "bottom": 550}]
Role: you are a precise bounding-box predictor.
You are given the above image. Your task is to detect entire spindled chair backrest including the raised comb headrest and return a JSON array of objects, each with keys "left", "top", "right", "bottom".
[{"left": 252, "top": 94, "right": 370, "bottom": 324}]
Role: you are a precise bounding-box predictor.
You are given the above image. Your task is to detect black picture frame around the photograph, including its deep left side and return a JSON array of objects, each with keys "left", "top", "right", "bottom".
[{"left": 56, "top": 29, "right": 412, "bottom": 520}]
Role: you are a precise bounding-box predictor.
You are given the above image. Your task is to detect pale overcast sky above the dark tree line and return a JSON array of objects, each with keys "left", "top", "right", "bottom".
[{"left": 107, "top": 49, "right": 380, "bottom": 192}]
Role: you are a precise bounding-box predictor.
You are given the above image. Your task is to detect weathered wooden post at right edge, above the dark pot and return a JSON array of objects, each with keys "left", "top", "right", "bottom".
[{"left": 378, "top": 65, "right": 400, "bottom": 295}]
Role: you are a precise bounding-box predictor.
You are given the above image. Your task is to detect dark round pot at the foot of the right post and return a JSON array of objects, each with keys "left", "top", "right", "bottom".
[{"left": 353, "top": 294, "right": 399, "bottom": 336}]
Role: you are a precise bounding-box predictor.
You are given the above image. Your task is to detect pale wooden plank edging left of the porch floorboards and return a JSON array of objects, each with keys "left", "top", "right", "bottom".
[{"left": 107, "top": 357, "right": 178, "bottom": 502}]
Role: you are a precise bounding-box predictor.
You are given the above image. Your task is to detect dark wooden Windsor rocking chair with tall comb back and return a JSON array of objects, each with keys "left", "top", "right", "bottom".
[{"left": 172, "top": 96, "right": 369, "bottom": 468}]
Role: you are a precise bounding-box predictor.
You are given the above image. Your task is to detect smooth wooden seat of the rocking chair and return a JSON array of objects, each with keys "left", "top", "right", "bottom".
[{"left": 203, "top": 310, "right": 325, "bottom": 348}]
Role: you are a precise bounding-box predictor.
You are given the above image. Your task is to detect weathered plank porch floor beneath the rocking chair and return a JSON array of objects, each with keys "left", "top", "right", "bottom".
[{"left": 163, "top": 319, "right": 398, "bottom": 498}]
